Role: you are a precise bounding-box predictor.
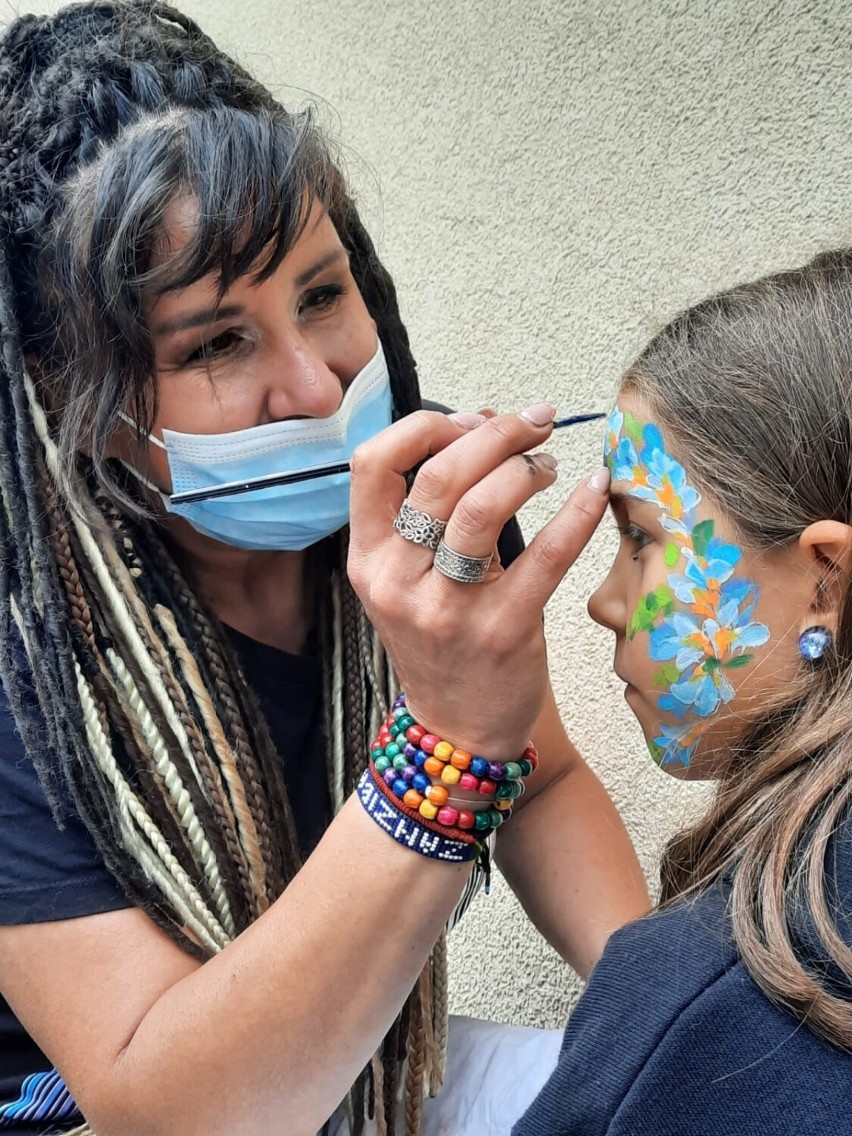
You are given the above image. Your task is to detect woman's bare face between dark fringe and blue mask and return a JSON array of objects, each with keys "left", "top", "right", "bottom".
[{"left": 136, "top": 199, "right": 377, "bottom": 492}]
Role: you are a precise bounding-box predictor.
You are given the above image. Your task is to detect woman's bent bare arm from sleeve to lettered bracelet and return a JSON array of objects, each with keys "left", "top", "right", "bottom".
[{"left": 0, "top": 800, "right": 469, "bottom": 1136}]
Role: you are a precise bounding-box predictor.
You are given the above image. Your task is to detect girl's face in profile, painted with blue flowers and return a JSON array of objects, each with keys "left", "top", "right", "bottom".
[{"left": 588, "top": 394, "right": 811, "bottom": 778}]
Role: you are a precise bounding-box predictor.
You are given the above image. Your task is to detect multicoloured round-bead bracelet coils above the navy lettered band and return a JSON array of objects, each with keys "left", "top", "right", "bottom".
[{"left": 370, "top": 694, "right": 538, "bottom": 835}]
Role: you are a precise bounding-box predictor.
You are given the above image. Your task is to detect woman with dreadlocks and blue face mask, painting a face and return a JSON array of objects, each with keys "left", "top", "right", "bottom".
[{"left": 0, "top": 0, "right": 646, "bottom": 1136}]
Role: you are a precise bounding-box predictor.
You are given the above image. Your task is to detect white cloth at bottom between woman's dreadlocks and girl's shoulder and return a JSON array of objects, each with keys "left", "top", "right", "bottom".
[{"left": 332, "top": 1017, "right": 562, "bottom": 1136}]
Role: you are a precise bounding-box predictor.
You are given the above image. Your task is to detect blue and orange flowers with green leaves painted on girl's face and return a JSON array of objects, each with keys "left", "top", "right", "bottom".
[{"left": 604, "top": 408, "right": 769, "bottom": 768}]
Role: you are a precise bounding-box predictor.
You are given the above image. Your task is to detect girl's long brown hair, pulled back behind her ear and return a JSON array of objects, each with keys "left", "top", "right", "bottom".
[{"left": 624, "top": 251, "right": 852, "bottom": 1049}]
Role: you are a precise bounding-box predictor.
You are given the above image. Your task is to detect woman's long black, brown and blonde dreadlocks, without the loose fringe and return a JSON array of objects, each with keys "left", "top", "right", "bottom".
[{"left": 0, "top": 0, "right": 445, "bottom": 1136}]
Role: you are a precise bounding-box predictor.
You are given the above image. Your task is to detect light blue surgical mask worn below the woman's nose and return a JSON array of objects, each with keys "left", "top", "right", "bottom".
[{"left": 128, "top": 343, "right": 392, "bottom": 552}]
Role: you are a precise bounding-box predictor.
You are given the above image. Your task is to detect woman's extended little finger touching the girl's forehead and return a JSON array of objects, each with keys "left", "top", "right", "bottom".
[{"left": 506, "top": 467, "right": 610, "bottom": 619}]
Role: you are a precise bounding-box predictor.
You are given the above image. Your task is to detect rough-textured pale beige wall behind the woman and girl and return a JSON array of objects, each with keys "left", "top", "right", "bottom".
[{"left": 10, "top": 0, "right": 852, "bottom": 1026}]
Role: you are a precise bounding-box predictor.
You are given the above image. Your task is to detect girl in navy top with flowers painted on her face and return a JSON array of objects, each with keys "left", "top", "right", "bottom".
[{"left": 513, "top": 252, "right": 852, "bottom": 1136}]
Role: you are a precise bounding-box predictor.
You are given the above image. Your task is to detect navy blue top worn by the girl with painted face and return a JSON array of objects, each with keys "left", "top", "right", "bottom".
[{"left": 512, "top": 821, "right": 852, "bottom": 1136}]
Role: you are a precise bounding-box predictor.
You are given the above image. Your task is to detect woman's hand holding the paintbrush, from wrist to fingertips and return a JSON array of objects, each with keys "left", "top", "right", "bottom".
[{"left": 349, "top": 403, "right": 608, "bottom": 760}]
